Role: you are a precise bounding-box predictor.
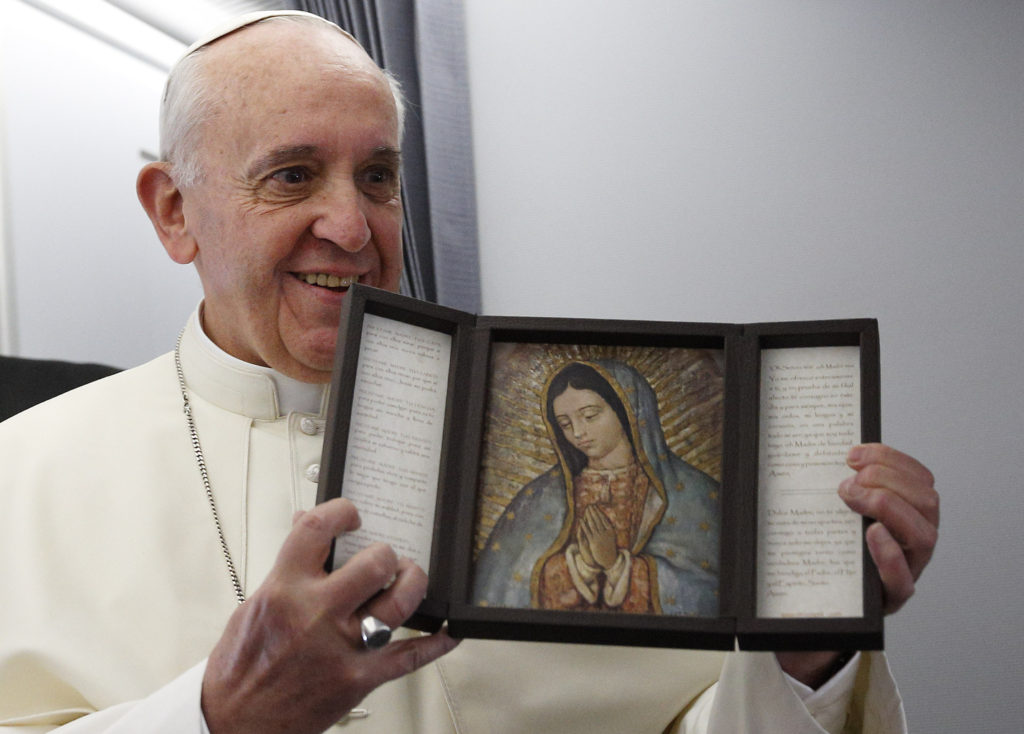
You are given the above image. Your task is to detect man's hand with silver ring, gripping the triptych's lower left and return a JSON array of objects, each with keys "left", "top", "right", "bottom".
[{"left": 203, "top": 499, "right": 457, "bottom": 734}]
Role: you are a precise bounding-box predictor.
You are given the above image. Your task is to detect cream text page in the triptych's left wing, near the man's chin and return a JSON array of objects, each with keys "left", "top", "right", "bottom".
[{"left": 335, "top": 313, "right": 452, "bottom": 571}]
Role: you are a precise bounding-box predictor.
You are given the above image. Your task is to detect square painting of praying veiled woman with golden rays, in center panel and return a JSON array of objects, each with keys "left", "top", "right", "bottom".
[{"left": 473, "top": 343, "right": 724, "bottom": 617}]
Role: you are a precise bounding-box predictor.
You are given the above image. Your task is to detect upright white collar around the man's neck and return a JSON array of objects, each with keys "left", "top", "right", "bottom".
[{"left": 181, "top": 306, "right": 330, "bottom": 421}]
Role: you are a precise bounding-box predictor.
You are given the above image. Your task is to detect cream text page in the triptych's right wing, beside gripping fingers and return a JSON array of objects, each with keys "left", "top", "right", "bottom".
[{"left": 758, "top": 347, "right": 863, "bottom": 617}]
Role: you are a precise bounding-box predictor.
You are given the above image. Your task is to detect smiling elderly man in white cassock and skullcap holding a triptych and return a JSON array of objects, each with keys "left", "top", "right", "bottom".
[{"left": 0, "top": 12, "right": 938, "bottom": 734}]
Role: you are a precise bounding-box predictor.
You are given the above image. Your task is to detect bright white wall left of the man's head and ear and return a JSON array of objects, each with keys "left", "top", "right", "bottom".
[{"left": 0, "top": 0, "right": 201, "bottom": 366}]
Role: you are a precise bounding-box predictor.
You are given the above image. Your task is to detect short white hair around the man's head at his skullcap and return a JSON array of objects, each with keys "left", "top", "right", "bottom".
[{"left": 160, "top": 13, "right": 406, "bottom": 187}]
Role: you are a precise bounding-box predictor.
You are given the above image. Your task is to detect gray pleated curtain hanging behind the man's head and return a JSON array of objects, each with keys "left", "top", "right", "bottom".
[{"left": 295, "top": 0, "right": 480, "bottom": 312}]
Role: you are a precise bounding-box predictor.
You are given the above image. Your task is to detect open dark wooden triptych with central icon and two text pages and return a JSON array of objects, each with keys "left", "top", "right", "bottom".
[{"left": 317, "top": 286, "right": 883, "bottom": 650}]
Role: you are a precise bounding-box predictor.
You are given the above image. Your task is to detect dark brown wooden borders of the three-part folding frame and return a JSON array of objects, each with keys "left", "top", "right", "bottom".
[{"left": 317, "top": 286, "right": 883, "bottom": 650}]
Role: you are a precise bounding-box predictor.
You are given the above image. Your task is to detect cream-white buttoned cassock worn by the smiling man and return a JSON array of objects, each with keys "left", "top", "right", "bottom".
[{"left": 0, "top": 315, "right": 906, "bottom": 734}]
